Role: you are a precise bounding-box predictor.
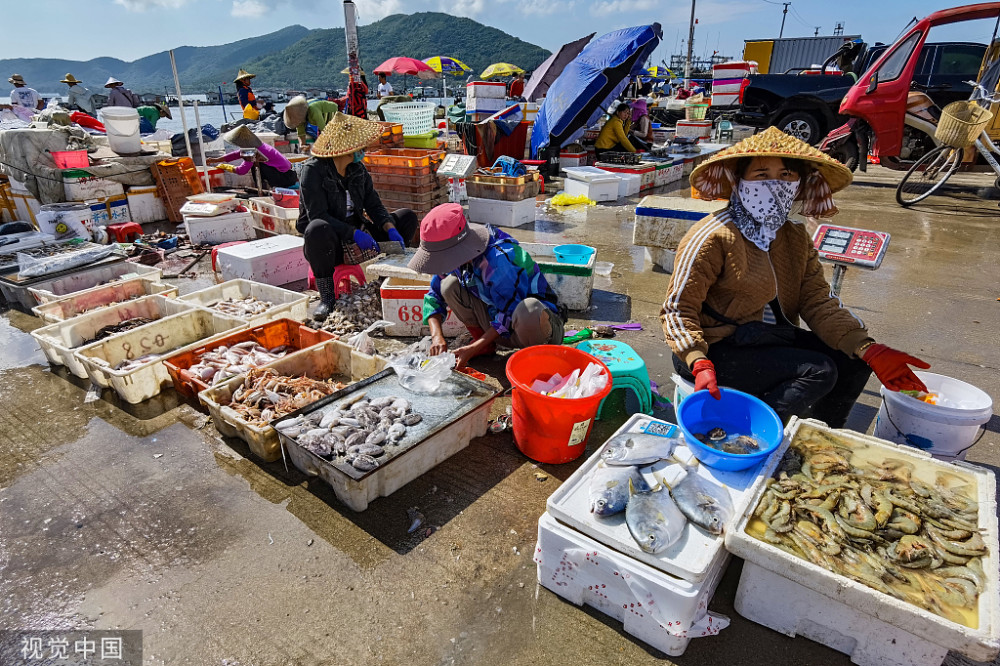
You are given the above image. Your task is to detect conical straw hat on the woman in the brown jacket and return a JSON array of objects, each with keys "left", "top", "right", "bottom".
[{"left": 691, "top": 127, "right": 853, "bottom": 199}]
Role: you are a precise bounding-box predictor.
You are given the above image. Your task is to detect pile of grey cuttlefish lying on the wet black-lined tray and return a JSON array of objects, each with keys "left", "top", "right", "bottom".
[{"left": 277, "top": 392, "right": 423, "bottom": 472}]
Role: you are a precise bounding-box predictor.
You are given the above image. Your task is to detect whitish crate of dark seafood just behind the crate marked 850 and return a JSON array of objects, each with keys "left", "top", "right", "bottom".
[{"left": 31, "top": 295, "right": 197, "bottom": 379}]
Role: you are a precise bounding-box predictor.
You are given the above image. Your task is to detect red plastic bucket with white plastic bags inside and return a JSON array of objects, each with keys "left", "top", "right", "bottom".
[{"left": 507, "top": 345, "right": 611, "bottom": 464}]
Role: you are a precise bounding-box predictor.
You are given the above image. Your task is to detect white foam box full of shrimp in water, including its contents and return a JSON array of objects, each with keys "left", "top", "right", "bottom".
[{"left": 726, "top": 418, "right": 1000, "bottom": 666}]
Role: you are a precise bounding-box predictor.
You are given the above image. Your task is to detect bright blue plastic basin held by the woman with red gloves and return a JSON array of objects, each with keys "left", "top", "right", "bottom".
[{"left": 677, "top": 388, "right": 785, "bottom": 471}]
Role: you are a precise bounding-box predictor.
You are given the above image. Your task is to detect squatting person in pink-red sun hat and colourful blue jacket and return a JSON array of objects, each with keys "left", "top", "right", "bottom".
[{"left": 409, "top": 203, "right": 563, "bottom": 368}]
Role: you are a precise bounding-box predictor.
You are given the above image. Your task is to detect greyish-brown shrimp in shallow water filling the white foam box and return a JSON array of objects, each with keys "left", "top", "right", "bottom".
[{"left": 746, "top": 427, "right": 984, "bottom": 626}]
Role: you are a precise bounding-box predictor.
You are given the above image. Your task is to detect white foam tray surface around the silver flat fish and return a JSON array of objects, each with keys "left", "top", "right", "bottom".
[{"left": 547, "top": 414, "right": 788, "bottom": 582}]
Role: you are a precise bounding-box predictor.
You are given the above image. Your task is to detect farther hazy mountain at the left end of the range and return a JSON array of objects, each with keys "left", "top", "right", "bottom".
[{"left": 0, "top": 25, "right": 310, "bottom": 93}]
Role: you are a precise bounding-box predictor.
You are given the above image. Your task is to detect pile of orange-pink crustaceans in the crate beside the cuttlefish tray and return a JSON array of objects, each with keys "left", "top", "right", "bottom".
[{"left": 229, "top": 368, "right": 344, "bottom": 428}]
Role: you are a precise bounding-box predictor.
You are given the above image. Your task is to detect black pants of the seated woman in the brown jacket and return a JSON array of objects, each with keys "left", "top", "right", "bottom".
[{"left": 674, "top": 330, "right": 872, "bottom": 428}]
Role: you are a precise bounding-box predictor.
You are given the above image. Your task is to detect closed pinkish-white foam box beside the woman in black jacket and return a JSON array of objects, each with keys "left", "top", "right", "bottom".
[{"left": 216, "top": 234, "right": 309, "bottom": 287}]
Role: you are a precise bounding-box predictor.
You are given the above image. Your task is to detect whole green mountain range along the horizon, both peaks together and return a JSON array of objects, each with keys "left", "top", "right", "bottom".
[{"left": 0, "top": 12, "right": 549, "bottom": 94}]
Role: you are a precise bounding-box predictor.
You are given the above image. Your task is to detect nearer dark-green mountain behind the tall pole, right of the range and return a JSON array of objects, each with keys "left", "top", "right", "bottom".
[{"left": 246, "top": 12, "right": 549, "bottom": 89}]
